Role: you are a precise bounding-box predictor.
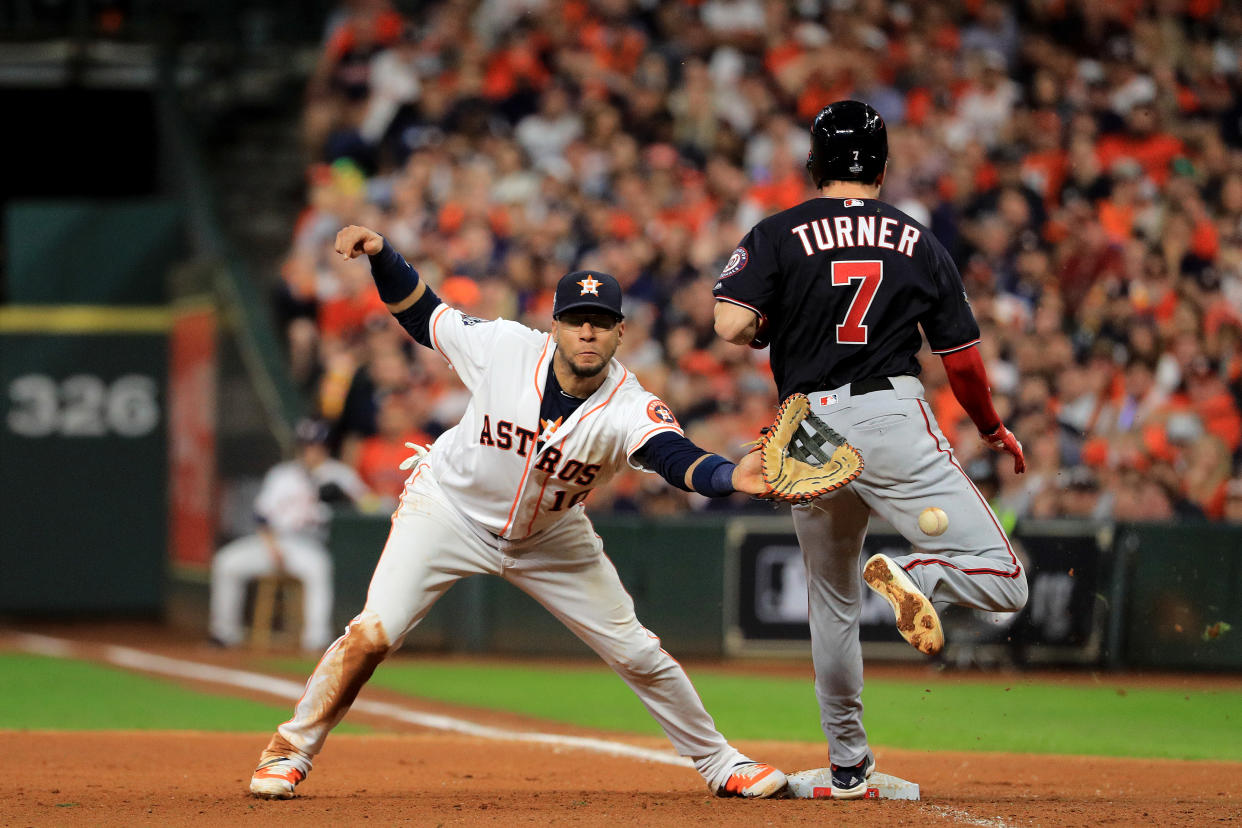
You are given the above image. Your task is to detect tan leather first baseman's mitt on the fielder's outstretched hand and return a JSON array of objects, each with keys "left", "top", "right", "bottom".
[{"left": 759, "top": 394, "right": 862, "bottom": 503}]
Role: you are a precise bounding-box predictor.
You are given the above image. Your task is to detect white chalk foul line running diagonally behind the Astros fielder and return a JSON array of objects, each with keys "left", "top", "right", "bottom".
[{"left": 12, "top": 633, "right": 692, "bottom": 767}]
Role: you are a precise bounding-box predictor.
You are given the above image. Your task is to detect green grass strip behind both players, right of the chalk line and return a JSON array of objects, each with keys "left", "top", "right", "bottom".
[{"left": 273, "top": 660, "right": 1242, "bottom": 761}]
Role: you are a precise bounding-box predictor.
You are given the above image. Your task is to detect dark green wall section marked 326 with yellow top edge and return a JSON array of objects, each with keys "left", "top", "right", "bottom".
[{"left": 0, "top": 314, "right": 170, "bottom": 614}]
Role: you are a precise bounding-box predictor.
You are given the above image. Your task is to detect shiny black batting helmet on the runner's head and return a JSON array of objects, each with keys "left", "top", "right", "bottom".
[{"left": 806, "top": 101, "right": 888, "bottom": 187}]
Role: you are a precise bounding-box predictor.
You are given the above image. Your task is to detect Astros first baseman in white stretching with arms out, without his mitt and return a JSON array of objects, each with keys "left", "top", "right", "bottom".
[{"left": 250, "top": 226, "right": 786, "bottom": 799}]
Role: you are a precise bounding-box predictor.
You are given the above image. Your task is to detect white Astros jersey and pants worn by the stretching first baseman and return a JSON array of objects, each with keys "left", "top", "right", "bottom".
[{"left": 265, "top": 304, "right": 745, "bottom": 788}]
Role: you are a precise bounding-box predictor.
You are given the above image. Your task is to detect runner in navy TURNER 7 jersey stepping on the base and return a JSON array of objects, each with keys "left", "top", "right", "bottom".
[{"left": 714, "top": 101, "right": 1027, "bottom": 798}]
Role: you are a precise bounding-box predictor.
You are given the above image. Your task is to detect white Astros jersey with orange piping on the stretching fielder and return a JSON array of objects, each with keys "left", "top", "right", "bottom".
[{"left": 428, "top": 304, "right": 682, "bottom": 540}]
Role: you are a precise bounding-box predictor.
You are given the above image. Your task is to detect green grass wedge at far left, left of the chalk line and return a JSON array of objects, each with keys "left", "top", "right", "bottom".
[{"left": 0, "top": 653, "right": 361, "bottom": 732}]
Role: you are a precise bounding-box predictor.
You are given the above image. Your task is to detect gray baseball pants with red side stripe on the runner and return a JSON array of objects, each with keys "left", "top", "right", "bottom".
[{"left": 792, "top": 376, "right": 1027, "bottom": 765}]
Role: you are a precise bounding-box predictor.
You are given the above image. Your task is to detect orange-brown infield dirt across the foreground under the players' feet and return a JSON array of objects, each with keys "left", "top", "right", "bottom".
[{"left": 0, "top": 731, "right": 1242, "bottom": 827}]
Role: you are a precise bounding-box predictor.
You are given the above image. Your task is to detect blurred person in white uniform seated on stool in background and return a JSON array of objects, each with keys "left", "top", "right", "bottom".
[{"left": 209, "top": 420, "right": 369, "bottom": 650}]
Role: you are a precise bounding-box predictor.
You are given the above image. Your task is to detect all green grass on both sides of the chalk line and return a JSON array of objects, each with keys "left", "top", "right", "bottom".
[{"left": 7, "top": 653, "right": 1242, "bottom": 761}]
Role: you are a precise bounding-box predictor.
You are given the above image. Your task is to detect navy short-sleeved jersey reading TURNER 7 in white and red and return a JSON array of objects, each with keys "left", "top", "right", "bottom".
[{"left": 713, "top": 197, "right": 979, "bottom": 400}]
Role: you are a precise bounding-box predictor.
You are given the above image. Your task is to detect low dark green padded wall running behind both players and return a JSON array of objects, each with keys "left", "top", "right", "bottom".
[{"left": 332, "top": 515, "right": 1242, "bottom": 669}]
